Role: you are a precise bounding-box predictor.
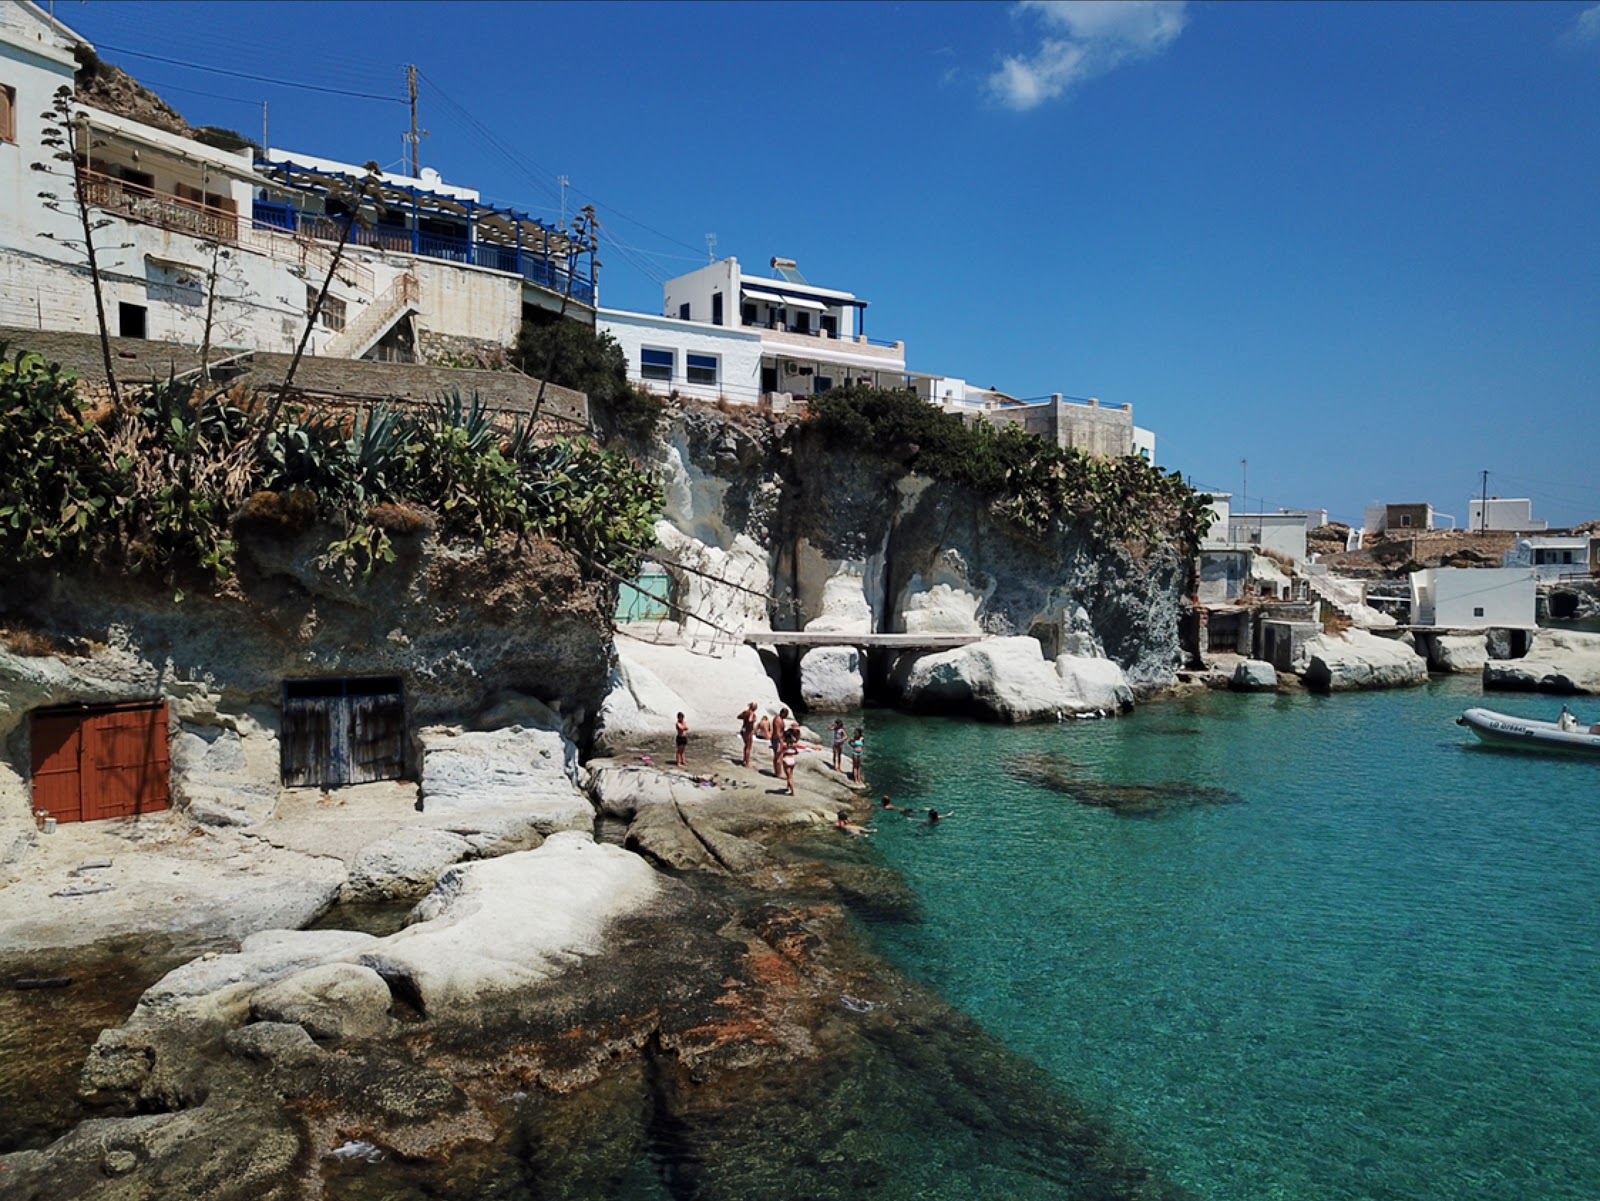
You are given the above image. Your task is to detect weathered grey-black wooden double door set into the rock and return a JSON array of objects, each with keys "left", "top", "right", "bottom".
[{"left": 278, "top": 676, "right": 405, "bottom": 788}]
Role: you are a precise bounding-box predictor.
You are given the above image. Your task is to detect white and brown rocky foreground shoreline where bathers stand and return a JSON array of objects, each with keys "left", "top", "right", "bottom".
[{"left": 0, "top": 710, "right": 1179, "bottom": 1201}]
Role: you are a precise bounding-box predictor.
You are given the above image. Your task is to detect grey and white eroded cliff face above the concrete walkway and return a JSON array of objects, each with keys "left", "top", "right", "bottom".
[{"left": 658, "top": 409, "right": 1189, "bottom": 703}]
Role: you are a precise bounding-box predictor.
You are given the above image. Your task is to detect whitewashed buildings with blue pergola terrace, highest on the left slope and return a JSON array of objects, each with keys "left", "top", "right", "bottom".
[{"left": 0, "top": 0, "right": 597, "bottom": 360}]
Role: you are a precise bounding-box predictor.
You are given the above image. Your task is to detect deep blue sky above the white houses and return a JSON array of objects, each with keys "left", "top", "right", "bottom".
[{"left": 56, "top": 0, "right": 1600, "bottom": 525}]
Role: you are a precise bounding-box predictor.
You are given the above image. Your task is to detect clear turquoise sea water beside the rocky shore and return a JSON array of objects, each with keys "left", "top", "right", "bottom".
[{"left": 867, "top": 681, "right": 1600, "bottom": 1201}]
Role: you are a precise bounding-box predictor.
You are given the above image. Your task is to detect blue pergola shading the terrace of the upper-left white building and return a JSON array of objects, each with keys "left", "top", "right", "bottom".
[{"left": 254, "top": 158, "right": 597, "bottom": 307}]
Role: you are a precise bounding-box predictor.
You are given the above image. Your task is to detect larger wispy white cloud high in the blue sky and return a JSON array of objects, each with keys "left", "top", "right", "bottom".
[{"left": 989, "top": 0, "right": 1190, "bottom": 112}]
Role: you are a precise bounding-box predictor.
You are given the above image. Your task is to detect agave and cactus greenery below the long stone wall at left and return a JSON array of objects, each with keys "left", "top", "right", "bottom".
[{"left": 0, "top": 345, "right": 661, "bottom": 581}]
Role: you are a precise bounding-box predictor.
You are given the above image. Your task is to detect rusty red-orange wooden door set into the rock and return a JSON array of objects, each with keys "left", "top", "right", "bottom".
[{"left": 30, "top": 702, "right": 171, "bottom": 822}]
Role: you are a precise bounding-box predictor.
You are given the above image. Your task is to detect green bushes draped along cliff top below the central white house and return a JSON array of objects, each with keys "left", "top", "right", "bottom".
[{"left": 802, "top": 387, "right": 1210, "bottom": 552}]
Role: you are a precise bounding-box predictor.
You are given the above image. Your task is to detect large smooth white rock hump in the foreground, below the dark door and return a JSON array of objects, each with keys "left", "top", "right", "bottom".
[{"left": 352, "top": 833, "right": 661, "bottom": 1020}]
